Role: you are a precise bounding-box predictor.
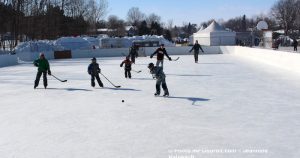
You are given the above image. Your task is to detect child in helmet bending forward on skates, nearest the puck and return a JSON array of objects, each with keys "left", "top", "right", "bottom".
[{"left": 148, "top": 63, "right": 169, "bottom": 97}]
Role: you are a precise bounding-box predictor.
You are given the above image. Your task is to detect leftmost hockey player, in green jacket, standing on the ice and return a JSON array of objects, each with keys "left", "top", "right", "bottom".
[{"left": 33, "top": 53, "right": 51, "bottom": 89}]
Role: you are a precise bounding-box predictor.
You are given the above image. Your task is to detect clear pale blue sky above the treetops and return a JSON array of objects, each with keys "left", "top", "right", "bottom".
[{"left": 107, "top": 0, "right": 277, "bottom": 26}]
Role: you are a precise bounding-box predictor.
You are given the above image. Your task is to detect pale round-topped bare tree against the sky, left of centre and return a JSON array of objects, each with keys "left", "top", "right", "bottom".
[{"left": 127, "top": 7, "right": 145, "bottom": 26}]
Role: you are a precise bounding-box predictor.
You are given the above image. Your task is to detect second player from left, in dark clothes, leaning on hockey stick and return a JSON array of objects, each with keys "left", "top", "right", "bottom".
[{"left": 88, "top": 57, "right": 103, "bottom": 87}]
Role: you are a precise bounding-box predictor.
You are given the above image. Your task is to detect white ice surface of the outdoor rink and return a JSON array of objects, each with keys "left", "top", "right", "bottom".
[{"left": 0, "top": 54, "right": 300, "bottom": 158}]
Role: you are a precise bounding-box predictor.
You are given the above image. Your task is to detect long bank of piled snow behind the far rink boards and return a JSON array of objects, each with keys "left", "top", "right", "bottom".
[{"left": 16, "top": 35, "right": 175, "bottom": 52}]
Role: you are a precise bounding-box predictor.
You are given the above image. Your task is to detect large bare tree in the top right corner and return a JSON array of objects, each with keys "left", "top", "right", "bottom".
[{"left": 271, "top": 0, "right": 299, "bottom": 35}]
